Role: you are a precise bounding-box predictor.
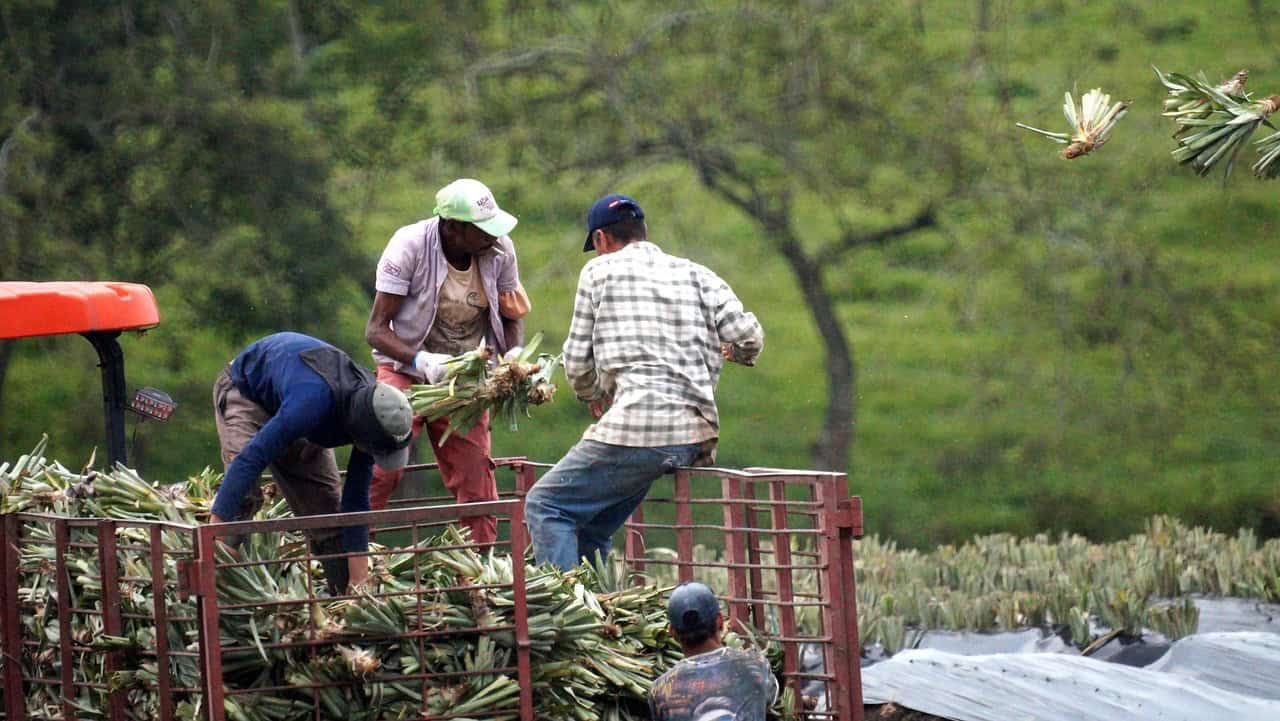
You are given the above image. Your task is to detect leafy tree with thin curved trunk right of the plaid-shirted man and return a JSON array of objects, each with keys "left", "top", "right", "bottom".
[{"left": 467, "top": 1, "right": 964, "bottom": 469}]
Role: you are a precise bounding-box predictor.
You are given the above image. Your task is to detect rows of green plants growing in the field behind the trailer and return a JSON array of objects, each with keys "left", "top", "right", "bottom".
[{"left": 637, "top": 516, "right": 1280, "bottom": 654}]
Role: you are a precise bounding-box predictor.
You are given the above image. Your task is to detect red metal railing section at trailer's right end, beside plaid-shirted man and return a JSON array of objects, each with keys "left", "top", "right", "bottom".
[{"left": 623, "top": 469, "right": 863, "bottom": 721}]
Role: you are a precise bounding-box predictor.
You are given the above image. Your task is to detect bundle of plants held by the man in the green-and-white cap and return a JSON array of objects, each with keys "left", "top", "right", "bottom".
[{"left": 406, "top": 333, "right": 562, "bottom": 443}]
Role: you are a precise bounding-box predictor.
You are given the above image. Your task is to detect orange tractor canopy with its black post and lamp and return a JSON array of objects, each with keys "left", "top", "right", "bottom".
[{"left": 0, "top": 282, "right": 174, "bottom": 464}]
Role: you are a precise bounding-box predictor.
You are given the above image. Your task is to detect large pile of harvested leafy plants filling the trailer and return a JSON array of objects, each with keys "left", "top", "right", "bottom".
[{"left": 0, "top": 442, "right": 791, "bottom": 721}]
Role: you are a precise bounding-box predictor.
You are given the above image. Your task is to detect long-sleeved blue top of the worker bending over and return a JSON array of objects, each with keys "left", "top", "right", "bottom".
[{"left": 212, "top": 333, "right": 374, "bottom": 551}]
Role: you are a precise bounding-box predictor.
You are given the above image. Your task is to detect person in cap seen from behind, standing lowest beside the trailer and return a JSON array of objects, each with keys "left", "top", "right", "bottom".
[{"left": 649, "top": 581, "right": 778, "bottom": 721}]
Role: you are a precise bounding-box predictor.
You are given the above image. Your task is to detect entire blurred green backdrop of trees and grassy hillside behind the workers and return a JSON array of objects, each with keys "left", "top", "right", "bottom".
[{"left": 0, "top": 0, "right": 1280, "bottom": 543}]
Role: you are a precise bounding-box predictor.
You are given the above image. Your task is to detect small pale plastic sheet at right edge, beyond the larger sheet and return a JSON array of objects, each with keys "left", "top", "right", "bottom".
[{"left": 1147, "top": 631, "right": 1280, "bottom": 701}]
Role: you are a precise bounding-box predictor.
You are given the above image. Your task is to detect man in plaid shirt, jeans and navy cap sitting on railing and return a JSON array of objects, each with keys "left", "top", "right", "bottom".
[{"left": 525, "top": 193, "right": 764, "bottom": 570}]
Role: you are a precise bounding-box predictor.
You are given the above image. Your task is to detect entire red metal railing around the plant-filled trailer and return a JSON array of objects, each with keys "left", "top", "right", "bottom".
[{"left": 0, "top": 458, "right": 863, "bottom": 721}]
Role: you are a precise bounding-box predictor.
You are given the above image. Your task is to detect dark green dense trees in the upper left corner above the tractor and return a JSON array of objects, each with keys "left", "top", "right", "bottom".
[{"left": 0, "top": 1, "right": 364, "bottom": 425}]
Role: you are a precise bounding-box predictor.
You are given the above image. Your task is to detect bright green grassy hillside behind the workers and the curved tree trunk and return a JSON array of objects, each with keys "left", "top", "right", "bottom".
[{"left": 0, "top": 0, "right": 1280, "bottom": 546}]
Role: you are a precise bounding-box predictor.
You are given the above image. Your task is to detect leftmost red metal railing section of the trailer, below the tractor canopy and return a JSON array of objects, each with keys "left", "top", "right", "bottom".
[{"left": 0, "top": 514, "right": 201, "bottom": 721}]
